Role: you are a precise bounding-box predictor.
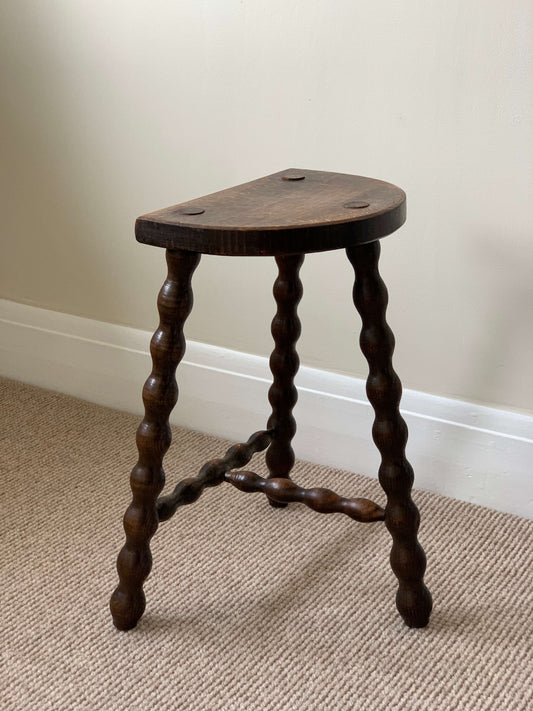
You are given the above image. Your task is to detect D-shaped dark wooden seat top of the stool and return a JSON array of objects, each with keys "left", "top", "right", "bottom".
[{"left": 135, "top": 168, "right": 405, "bottom": 255}]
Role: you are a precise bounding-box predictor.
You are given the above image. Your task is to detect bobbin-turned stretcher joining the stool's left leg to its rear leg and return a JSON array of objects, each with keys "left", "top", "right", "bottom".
[{"left": 157, "top": 430, "right": 272, "bottom": 521}]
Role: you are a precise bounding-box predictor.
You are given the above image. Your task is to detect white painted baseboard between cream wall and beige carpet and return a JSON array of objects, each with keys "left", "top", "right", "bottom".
[{"left": 0, "top": 300, "right": 533, "bottom": 518}]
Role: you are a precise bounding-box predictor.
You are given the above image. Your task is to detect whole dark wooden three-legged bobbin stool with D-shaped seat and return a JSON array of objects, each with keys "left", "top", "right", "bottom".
[{"left": 111, "top": 169, "right": 431, "bottom": 630}]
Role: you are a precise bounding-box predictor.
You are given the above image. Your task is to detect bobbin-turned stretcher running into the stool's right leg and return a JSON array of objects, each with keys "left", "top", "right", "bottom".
[{"left": 225, "top": 472, "right": 385, "bottom": 523}]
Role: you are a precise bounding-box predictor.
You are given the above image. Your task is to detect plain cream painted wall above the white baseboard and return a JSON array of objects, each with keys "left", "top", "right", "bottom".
[{"left": 0, "top": 0, "right": 533, "bottom": 413}]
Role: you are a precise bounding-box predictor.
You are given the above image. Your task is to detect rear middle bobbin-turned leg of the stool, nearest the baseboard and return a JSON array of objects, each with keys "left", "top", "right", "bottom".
[{"left": 266, "top": 254, "right": 304, "bottom": 508}]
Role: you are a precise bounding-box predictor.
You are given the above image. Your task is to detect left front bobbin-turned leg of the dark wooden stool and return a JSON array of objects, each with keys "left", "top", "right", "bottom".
[{"left": 110, "top": 250, "right": 200, "bottom": 630}]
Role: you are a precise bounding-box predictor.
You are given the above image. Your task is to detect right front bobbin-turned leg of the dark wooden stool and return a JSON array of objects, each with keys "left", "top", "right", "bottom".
[{"left": 346, "top": 241, "right": 432, "bottom": 627}]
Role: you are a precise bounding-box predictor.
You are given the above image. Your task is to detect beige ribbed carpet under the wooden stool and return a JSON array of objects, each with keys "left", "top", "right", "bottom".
[{"left": 0, "top": 380, "right": 533, "bottom": 711}]
